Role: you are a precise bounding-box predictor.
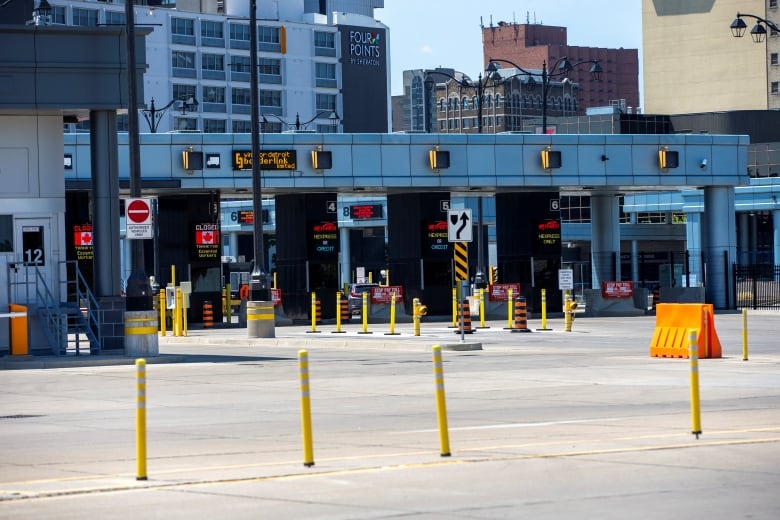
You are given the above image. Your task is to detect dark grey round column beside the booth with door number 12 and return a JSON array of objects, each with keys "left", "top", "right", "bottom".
[{"left": 89, "top": 110, "right": 121, "bottom": 297}]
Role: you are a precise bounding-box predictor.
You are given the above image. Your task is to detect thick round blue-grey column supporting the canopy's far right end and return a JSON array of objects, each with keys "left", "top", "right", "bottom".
[{"left": 703, "top": 186, "right": 737, "bottom": 309}]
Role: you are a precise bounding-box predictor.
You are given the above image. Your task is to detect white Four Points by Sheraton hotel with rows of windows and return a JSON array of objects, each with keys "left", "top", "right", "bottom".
[{"left": 42, "top": 0, "right": 390, "bottom": 133}]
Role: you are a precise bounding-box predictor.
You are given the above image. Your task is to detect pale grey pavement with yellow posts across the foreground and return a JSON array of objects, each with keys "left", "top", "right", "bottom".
[{"left": 0, "top": 311, "right": 780, "bottom": 519}]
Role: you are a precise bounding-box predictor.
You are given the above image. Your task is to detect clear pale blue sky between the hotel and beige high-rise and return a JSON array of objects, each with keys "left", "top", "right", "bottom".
[{"left": 375, "top": 0, "right": 642, "bottom": 96}]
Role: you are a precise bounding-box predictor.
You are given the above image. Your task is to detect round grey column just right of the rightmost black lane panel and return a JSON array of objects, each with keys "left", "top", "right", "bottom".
[{"left": 590, "top": 194, "right": 620, "bottom": 289}]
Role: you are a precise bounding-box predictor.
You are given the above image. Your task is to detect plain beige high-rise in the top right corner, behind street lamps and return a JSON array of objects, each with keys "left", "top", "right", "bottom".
[{"left": 642, "top": 0, "right": 780, "bottom": 114}]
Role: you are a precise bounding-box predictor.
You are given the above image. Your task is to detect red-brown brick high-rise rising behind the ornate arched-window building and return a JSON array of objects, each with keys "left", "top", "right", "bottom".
[{"left": 482, "top": 22, "right": 639, "bottom": 115}]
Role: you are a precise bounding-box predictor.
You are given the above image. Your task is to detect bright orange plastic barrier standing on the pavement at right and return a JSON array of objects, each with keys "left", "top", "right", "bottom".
[{"left": 650, "top": 303, "right": 721, "bottom": 358}]
